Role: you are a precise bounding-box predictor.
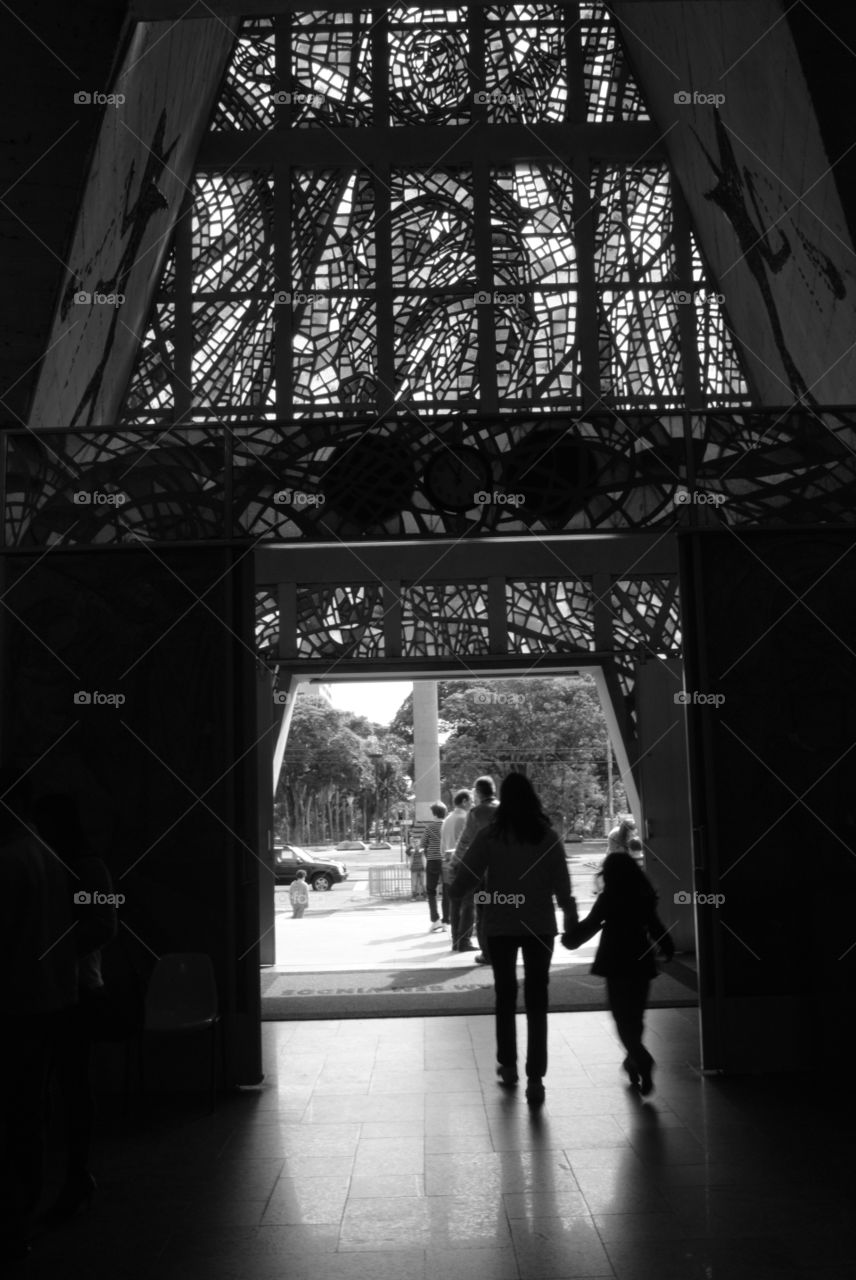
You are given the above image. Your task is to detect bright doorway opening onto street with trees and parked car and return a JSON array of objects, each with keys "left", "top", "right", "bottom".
[{"left": 262, "top": 663, "right": 695, "bottom": 1020}]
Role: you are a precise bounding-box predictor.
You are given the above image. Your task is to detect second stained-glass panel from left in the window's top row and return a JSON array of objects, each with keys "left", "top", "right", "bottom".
[{"left": 290, "top": 9, "right": 376, "bottom": 128}]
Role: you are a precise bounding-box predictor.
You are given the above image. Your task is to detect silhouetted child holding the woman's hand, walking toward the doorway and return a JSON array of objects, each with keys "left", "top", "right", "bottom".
[{"left": 562, "top": 852, "right": 674, "bottom": 1097}]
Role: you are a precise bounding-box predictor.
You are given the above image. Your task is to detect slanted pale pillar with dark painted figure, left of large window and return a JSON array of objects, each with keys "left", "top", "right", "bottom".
[{"left": 29, "top": 15, "right": 238, "bottom": 429}]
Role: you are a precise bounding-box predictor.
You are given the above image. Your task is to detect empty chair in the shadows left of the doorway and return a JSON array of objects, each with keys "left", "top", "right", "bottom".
[{"left": 133, "top": 951, "right": 223, "bottom": 1111}]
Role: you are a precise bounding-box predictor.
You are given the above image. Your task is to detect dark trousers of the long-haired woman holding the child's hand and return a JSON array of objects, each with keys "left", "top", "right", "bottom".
[{"left": 490, "top": 934, "right": 555, "bottom": 1080}]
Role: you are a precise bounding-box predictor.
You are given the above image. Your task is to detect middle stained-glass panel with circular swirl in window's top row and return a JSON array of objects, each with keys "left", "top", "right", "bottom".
[{"left": 384, "top": 5, "right": 471, "bottom": 125}]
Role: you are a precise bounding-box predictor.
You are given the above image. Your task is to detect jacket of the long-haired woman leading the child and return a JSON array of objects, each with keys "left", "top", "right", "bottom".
[{"left": 449, "top": 829, "right": 577, "bottom": 938}]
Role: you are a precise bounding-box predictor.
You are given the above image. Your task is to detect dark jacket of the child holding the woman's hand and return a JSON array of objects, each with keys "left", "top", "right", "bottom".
[{"left": 563, "top": 890, "right": 674, "bottom": 978}]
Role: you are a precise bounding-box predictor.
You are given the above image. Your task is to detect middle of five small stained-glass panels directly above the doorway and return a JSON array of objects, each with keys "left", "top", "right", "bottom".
[{"left": 400, "top": 582, "right": 490, "bottom": 658}]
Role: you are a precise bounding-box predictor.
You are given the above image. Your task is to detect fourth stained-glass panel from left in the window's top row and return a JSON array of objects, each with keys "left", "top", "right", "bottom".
[{"left": 485, "top": 4, "right": 573, "bottom": 124}]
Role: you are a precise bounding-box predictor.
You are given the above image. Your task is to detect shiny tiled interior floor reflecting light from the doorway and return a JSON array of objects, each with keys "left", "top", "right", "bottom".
[{"left": 23, "top": 1010, "right": 856, "bottom": 1280}]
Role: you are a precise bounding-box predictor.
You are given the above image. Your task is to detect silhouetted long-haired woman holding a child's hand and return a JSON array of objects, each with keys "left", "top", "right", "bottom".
[{"left": 450, "top": 773, "right": 577, "bottom": 1106}]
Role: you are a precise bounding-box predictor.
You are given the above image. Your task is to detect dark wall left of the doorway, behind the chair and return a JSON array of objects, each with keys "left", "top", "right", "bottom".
[{"left": 1, "top": 549, "right": 260, "bottom": 1083}]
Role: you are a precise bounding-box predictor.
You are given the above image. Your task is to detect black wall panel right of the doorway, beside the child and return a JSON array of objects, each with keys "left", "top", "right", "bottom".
[{"left": 681, "top": 531, "right": 856, "bottom": 1070}]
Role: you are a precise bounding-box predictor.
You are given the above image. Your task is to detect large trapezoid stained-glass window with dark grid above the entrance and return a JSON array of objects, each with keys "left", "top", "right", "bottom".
[{"left": 120, "top": 4, "right": 749, "bottom": 422}]
